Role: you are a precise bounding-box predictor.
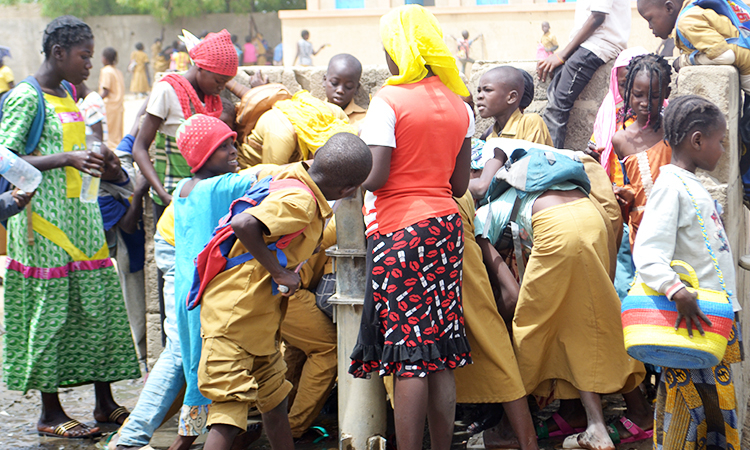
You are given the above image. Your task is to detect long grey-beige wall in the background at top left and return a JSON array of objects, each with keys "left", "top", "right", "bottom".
[{"left": 0, "top": 4, "right": 281, "bottom": 89}]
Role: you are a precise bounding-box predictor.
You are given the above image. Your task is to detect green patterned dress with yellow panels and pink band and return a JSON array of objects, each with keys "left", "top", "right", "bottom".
[{"left": 0, "top": 83, "right": 140, "bottom": 392}]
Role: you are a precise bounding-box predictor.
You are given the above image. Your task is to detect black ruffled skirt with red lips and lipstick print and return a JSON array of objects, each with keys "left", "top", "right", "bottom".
[{"left": 349, "top": 214, "right": 471, "bottom": 378}]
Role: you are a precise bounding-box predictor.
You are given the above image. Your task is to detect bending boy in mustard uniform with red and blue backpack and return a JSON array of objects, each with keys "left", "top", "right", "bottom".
[{"left": 198, "top": 133, "right": 372, "bottom": 450}]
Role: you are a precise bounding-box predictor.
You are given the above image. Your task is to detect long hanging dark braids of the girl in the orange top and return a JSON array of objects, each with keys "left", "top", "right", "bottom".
[{"left": 620, "top": 53, "right": 672, "bottom": 131}]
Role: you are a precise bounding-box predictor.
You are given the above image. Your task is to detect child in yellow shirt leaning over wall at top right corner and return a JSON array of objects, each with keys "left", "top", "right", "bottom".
[{"left": 638, "top": 0, "right": 750, "bottom": 93}]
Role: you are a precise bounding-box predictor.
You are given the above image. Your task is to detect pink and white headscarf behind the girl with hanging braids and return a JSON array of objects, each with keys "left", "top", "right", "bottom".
[{"left": 594, "top": 47, "right": 648, "bottom": 174}]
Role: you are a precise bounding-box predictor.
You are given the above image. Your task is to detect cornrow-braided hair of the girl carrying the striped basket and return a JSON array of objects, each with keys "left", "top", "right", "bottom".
[{"left": 664, "top": 95, "right": 724, "bottom": 149}]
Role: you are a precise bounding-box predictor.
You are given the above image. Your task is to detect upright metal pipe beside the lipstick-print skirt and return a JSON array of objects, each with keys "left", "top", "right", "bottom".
[{"left": 328, "top": 191, "right": 386, "bottom": 450}]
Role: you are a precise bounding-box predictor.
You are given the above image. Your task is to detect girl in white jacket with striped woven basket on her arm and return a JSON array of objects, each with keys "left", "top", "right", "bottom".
[{"left": 633, "top": 95, "right": 744, "bottom": 450}]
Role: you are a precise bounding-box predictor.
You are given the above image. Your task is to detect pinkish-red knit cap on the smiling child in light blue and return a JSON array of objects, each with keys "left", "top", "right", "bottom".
[{"left": 177, "top": 114, "right": 237, "bottom": 173}]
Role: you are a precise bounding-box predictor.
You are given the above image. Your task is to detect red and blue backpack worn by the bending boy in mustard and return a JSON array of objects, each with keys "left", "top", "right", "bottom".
[{"left": 186, "top": 176, "right": 317, "bottom": 310}]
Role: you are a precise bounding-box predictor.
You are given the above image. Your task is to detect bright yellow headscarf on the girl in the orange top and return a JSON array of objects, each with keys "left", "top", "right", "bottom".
[{"left": 380, "top": 5, "right": 469, "bottom": 97}]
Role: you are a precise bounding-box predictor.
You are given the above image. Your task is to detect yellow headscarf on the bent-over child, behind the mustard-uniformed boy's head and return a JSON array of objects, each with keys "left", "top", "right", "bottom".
[{"left": 273, "top": 90, "right": 357, "bottom": 159}]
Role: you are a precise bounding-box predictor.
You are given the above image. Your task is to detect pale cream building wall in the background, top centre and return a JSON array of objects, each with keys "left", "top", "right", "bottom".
[{"left": 279, "top": 0, "right": 661, "bottom": 65}]
